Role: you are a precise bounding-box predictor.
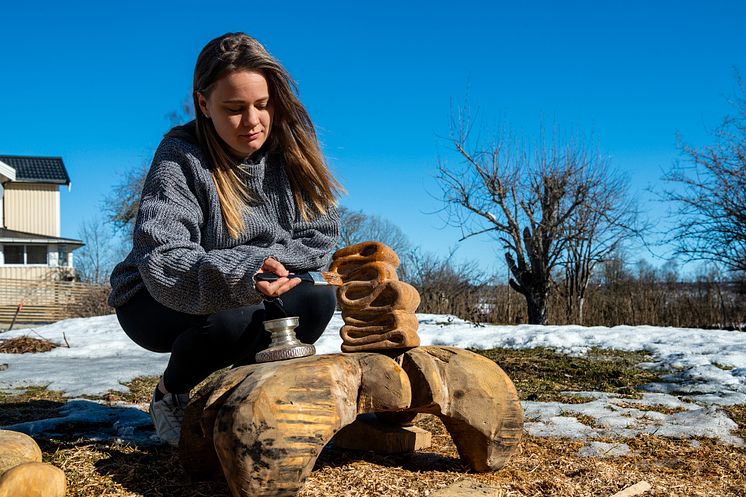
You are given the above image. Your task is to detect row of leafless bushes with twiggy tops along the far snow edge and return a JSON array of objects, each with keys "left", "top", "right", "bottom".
[{"left": 409, "top": 255, "right": 746, "bottom": 331}]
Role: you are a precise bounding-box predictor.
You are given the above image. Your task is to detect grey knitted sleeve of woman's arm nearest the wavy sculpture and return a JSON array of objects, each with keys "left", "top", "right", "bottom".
[{"left": 280, "top": 205, "right": 339, "bottom": 272}]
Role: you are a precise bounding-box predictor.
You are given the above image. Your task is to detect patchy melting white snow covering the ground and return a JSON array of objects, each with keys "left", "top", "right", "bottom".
[{"left": 0, "top": 313, "right": 746, "bottom": 446}]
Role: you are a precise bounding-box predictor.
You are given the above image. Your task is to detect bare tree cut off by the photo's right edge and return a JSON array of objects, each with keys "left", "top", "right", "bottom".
[{"left": 663, "top": 78, "right": 746, "bottom": 273}]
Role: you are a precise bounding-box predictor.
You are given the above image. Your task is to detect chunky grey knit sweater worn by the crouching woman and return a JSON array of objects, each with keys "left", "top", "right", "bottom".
[{"left": 109, "top": 131, "right": 339, "bottom": 314}]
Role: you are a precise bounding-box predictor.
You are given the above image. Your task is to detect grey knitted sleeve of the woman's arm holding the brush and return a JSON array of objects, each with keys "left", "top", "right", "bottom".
[{"left": 133, "top": 145, "right": 273, "bottom": 314}]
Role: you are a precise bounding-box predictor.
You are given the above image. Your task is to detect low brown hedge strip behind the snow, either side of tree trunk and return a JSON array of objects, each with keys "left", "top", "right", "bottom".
[{"left": 418, "top": 266, "right": 746, "bottom": 331}]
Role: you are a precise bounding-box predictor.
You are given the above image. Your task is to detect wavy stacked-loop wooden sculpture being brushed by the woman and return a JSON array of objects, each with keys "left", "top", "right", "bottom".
[{"left": 330, "top": 242, "right": 420, "bottom": 352}]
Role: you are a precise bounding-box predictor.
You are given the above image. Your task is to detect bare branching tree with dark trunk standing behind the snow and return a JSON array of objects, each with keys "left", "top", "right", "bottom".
[{"left": 436, "top": 110, "right": 633, "bottom": 323}]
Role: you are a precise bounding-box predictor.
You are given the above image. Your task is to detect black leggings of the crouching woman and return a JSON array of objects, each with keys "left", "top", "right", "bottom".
[{"left": 117, "top": 283, "right": 336, "bottom": 393}]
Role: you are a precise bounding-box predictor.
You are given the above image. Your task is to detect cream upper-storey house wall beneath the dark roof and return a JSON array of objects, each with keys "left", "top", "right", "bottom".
[{"left": 5, "top": 182, "right": 60, "bottom": 237}]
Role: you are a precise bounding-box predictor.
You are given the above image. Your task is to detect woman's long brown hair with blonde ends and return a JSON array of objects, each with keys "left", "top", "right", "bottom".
[{"left": 193, "top": 33, "right": 344, "bottom": 239}]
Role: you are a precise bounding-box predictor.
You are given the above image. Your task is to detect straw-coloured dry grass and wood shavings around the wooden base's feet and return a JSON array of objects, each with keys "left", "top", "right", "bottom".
[{"left": 23, "top": 416, "right": 746, "bottom": 497}]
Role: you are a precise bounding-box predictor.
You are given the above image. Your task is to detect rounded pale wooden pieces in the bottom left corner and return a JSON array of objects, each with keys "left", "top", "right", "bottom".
[{"left": 0, "top": 430, "right": 67, "bottom": 497}]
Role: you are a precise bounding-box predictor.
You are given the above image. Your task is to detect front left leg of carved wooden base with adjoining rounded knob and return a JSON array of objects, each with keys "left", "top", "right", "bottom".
[{"left": 213, "top": 354, "right": 410, "bottom": 496}]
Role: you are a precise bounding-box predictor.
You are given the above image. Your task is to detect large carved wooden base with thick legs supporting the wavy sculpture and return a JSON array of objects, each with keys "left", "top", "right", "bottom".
[{"left": 180, "top": 347, "right": 523, "bottom": 497}]
